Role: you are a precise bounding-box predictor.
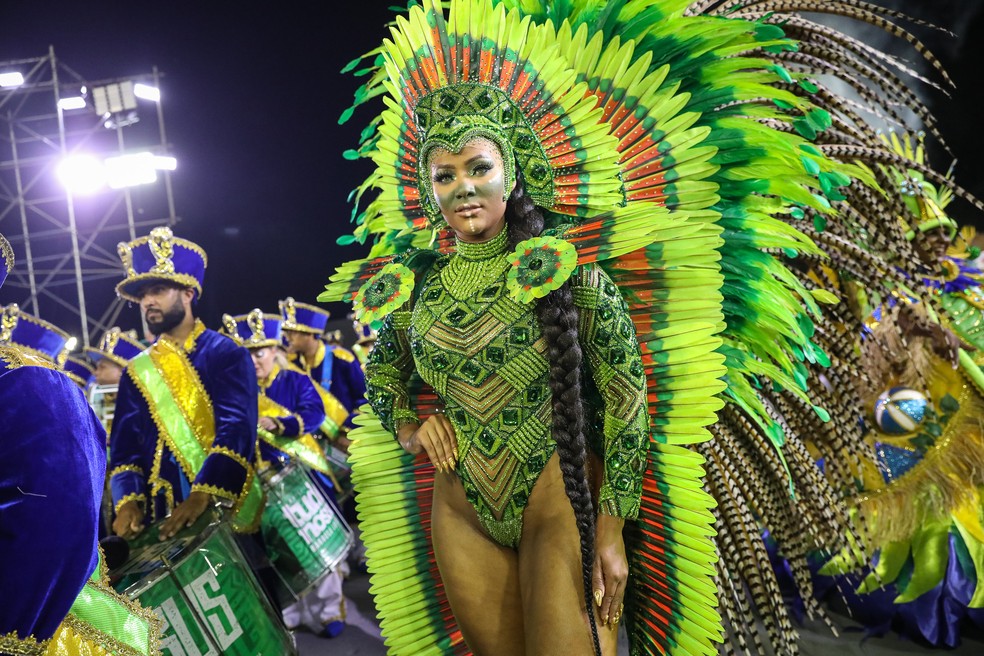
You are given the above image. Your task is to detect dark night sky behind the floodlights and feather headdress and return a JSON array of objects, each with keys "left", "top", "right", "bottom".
[{"left": 0, "top": 0, "right": 984, "bottom": 348}]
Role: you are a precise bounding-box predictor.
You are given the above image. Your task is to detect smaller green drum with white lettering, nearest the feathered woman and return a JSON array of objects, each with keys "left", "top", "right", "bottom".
[{"left": 261, "top": 462, "right": 353, "bottom": 607}]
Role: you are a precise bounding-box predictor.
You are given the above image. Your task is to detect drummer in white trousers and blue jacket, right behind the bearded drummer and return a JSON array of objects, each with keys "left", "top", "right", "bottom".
[{"left": 222, "top": 308, "right": 354, "bottom": 637}]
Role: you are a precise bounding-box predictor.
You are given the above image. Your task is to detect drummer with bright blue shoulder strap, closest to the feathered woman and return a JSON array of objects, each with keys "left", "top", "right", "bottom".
[{"left": 280, "top": 297, "right": 366, "bottom": 436}]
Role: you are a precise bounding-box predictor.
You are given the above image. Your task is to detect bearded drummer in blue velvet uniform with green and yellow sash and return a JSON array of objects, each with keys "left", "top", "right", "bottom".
[{"left": 110, "top": 227, "right": 263, "bottom": 540}]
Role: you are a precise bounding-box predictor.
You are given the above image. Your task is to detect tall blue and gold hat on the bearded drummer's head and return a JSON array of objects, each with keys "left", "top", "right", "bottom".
[{"left": 116, "top": 226, "right": 208, "bottom": 302}]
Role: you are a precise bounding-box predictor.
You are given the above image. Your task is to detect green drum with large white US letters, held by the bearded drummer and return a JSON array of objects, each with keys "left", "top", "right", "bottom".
[{"left": 110, "top": 512, "right": 297, "bottom": 656}]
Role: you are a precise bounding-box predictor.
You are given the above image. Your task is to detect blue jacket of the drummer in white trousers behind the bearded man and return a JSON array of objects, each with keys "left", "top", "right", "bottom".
[{"left": 259, "top": 367, "right": 325, "bottom": 462}]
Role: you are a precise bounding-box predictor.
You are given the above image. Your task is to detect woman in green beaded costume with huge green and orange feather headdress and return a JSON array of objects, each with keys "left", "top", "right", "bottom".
[{"left": 319, "top": 0, "right": 944, "bottom": 654}]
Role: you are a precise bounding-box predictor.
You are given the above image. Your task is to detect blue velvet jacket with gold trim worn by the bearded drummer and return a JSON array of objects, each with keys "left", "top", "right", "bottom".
[{"left": 109, "top": 322, "right": 257, "bottom": 524}]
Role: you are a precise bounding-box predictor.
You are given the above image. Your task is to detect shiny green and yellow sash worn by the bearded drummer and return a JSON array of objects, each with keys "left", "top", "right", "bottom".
[{"left": 128, "top": 340, "right": 263, "bottom": 531}]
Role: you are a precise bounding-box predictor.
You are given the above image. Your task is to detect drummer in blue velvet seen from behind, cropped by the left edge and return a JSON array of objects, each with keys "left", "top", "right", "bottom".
[{"left": 0, "top": 235, "right": 160, "bottom": 655}]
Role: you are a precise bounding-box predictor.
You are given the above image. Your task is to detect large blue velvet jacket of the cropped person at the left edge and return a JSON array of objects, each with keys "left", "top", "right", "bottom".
[{"left": 0, "top": 347, "right": 106, "bottom": 651}]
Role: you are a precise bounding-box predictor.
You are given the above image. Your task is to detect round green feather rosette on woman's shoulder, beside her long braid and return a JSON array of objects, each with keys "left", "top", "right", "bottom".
[{"left": 506, "top": 237, "right": 577, "bottom": 303}]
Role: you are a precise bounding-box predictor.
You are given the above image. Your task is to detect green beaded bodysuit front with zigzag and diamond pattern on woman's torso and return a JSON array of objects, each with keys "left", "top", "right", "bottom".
[{"left": 410, "top": 231, "right": 556, "bottom": 547}]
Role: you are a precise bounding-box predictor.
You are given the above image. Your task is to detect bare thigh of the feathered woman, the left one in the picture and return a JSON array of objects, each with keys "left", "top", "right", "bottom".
[{"left": 431, "top": 473, "right": 525, "bottom": 656}]
